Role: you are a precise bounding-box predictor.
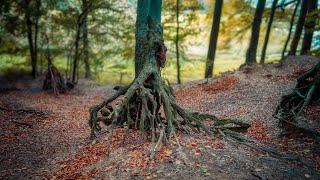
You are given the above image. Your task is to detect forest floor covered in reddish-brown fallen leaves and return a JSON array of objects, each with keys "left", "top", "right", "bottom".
[{"left": 0, "top": 56, "right": 320, "bottom": 179}]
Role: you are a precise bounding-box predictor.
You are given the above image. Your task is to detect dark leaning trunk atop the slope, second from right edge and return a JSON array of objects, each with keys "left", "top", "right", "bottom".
[{"left": 289, "top": 0, "right": 308, "bottom": 55}]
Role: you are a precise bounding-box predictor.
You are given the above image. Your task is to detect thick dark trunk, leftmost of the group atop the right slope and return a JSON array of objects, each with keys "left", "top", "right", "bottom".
[{"left": 245, "top": 0, "right": 266, "bottom": 64}]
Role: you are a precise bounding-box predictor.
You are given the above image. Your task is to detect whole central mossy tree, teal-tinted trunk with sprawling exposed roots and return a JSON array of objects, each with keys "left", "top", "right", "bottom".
[{"left": 89, "top": 0, "right": 249, "bottom": 142}]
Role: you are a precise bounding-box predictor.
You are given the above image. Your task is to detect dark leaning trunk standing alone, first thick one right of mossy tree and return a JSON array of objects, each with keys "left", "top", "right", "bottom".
[{"left": 205, "top": 0, "right": 223, "bottom": 78}]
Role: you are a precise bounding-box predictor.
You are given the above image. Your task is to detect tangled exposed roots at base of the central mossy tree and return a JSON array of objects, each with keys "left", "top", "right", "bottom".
[{"left": 89, "top": 59, "right": 249, "bottom": 144}]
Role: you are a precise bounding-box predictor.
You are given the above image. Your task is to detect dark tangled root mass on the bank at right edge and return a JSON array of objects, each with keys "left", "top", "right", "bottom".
[{"left": 274, "top": 62, "right": 320, "bottom": 137}]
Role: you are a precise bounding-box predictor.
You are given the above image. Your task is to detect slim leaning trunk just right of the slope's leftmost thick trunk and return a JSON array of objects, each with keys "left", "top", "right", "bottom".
[{"left": 260, "top": 0, "right": 278, "bottom": 64}]
